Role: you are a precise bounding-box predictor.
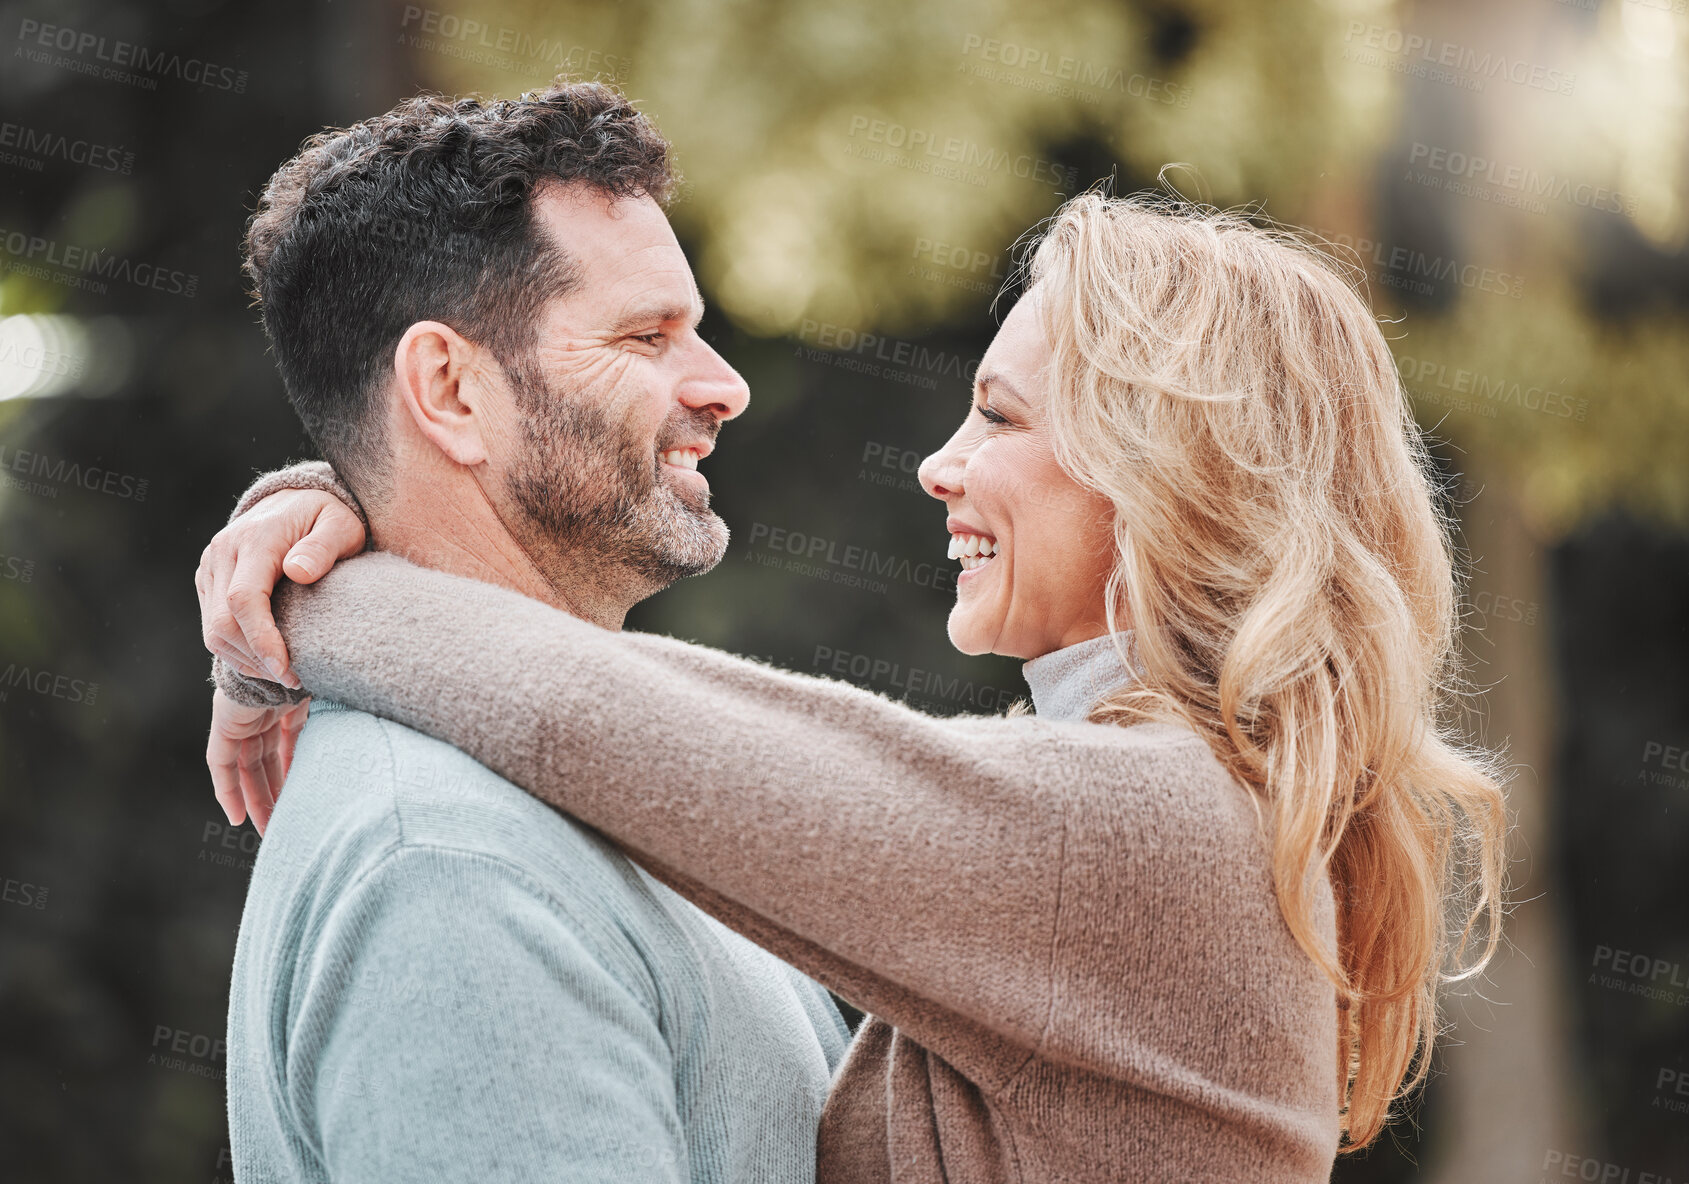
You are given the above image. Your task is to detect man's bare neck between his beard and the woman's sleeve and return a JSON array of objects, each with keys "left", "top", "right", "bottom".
[{"left": 370, "top": 493, "right": 642, "bottom": 632}]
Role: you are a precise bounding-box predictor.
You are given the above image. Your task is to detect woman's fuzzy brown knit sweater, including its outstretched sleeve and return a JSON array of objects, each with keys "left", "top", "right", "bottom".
[{"left": 217, "top": 466, "right": 1338, "bottom": 1184}]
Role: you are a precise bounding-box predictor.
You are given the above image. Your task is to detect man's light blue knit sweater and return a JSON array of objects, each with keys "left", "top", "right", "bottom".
[{"left": 228, "top": 701, "right": 848, "bottom": 1184}]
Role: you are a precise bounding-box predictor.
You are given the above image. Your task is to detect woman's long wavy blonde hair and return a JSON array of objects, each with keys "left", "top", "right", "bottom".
[{"left": 1030, "top": 193, "right": 1507, "bottom": 1150}]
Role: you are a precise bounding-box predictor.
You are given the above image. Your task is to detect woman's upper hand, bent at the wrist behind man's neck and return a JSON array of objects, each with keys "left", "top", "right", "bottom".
[{"left": 194, "top": 490, "right": 365, "bottom": 689}]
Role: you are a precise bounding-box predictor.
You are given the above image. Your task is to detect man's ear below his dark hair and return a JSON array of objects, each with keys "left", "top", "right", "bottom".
[{"left": 394, "top": 321, "right": 491, "bottom": 464}]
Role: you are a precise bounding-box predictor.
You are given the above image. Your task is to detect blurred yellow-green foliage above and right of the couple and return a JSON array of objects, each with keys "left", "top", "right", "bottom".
[{"left": 407, "top": 0, "right": 1689, "bottom": 535}]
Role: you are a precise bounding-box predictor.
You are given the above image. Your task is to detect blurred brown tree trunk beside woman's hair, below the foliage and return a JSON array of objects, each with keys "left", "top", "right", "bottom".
[{"left": 1427, "top": 458, "right": 1589, "bottom": 1184}]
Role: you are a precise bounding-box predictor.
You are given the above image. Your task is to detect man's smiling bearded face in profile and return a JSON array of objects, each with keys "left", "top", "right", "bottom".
[{"left": 495, "top": 187, "right": 750, "bottom": 593}]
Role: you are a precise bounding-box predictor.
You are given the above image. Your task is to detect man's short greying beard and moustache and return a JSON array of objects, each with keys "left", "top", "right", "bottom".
[{"left": 505, "top": 351, "right": 728, "bottom": 591}]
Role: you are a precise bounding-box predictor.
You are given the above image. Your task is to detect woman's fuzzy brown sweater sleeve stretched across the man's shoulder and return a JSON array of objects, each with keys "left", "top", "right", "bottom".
[{"left": 224, "top": 552, "right": 1067, "bottom": 1049}]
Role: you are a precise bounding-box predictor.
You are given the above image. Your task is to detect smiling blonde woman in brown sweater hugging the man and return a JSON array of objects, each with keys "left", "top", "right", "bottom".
[{"left": 201, "top": 194, "right": 1503, "bottom": 1181}]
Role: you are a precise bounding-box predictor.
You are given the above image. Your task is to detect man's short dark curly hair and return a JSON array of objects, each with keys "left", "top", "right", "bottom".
[{"left": 245, "top": 83, "right": 674, "bottom": 503}]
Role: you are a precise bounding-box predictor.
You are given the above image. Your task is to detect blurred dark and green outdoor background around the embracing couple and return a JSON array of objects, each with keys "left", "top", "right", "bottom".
[{"left": 0, "top": 0, "right": 1689, "bottom": 1184}]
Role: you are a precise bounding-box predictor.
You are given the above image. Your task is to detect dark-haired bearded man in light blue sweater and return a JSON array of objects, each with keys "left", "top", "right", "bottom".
[{"left": 198, "top": 84, "right": 848, "bottom": 1184}]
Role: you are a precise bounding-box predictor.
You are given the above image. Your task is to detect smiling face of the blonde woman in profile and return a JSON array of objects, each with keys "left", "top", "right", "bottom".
[{"left": 921, "top": 289, "right": 1115, "bottom": 659}]
